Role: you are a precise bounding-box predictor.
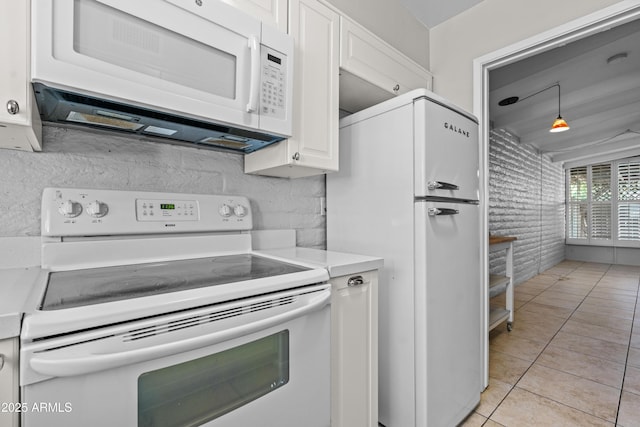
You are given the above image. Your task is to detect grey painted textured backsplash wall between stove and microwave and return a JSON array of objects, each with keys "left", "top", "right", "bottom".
[{"left": 0, "top": 125, "right": 326, "bottom": 248}]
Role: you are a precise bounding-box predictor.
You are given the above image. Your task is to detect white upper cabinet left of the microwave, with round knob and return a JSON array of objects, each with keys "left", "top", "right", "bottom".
[{"left": 0, "top": 1, "right": 42, "bottom": 151}]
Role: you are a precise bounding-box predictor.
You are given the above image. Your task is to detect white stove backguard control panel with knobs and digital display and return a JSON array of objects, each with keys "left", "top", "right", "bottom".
[{"left": 41, "top": 188, "right": 253, "bottom": 237}]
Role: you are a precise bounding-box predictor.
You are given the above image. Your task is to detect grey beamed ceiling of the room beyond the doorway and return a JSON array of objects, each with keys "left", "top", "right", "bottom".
[{"left": 489, "top": 20, "right": 640, "bottom": 164}]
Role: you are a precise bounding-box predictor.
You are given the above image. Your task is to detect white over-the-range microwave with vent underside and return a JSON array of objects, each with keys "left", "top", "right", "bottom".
[{"left": 31, "top": 0, "right": 294, "bottom": 153}]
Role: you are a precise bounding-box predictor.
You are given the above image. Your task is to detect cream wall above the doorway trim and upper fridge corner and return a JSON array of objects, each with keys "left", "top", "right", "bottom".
[{"left": 429, "top": 0, "right": 618, "bottom": 111}]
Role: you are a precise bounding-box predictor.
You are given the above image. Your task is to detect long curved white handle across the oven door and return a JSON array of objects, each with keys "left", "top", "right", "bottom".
[{"left": 29, "top": 288, "right": 331, "bottom": 377}]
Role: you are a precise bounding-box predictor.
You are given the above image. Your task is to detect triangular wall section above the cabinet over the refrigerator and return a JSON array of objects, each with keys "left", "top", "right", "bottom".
[{"left": 326, "top": 0, "right": 429, "bottom": 70}]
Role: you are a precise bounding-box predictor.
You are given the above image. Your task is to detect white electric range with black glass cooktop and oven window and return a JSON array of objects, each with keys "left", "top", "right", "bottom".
[{"left": 20, "top": 188, "right": 330, "bottom": 427}]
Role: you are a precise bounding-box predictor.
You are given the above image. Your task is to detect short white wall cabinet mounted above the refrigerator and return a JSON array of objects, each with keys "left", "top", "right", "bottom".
[{"left": 340, "top": 16, "right": 433, "bottom": 113}]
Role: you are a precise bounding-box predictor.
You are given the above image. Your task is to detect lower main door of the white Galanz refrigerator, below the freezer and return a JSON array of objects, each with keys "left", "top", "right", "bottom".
[{"left": 415, "top": 202, "right": 482, "bottom": 427}]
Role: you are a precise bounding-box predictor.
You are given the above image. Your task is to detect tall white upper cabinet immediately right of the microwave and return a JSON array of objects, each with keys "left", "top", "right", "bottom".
[{"left": 245, "top": 0, "right": 340, "bottom": 178}]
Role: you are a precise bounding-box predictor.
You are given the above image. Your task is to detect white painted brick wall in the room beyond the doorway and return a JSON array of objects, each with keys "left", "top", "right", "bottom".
[{"left": 489, "top": 130, "right": 565, "bottom": 283}]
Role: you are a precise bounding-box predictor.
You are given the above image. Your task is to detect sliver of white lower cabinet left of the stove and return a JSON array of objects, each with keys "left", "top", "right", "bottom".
[{"left": 0, "top": 338, "right": 22, "bottom": 427}]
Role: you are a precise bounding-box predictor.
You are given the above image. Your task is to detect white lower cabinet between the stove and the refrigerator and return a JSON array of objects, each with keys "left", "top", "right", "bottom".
[{"left": 330, "top": 270, "right": 378, "bottom": 427}]
